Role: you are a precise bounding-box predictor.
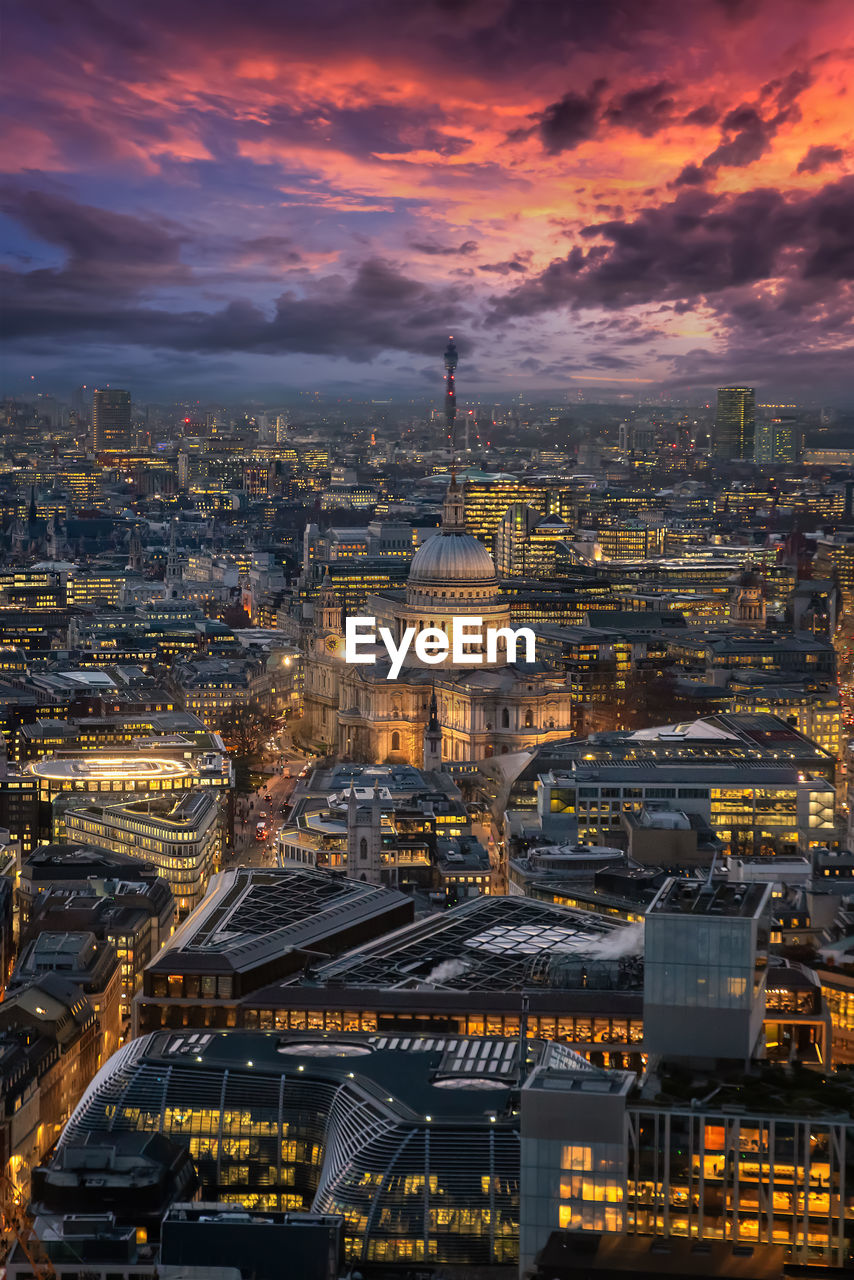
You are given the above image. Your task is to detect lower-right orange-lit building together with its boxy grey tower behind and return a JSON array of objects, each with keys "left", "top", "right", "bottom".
[{"left": 520, "top": 878, "right": 854, "bottom": 1274}]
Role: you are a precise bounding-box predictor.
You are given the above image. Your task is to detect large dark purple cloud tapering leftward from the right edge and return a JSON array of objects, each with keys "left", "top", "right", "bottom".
[{"left": 492, "top": 178, "right": 854, "bottom": 323}]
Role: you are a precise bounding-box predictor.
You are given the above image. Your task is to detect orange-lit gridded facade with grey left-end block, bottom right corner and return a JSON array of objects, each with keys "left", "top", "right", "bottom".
[{"left": 520, "top": 1057, "right": 854, "bottom": 1274}]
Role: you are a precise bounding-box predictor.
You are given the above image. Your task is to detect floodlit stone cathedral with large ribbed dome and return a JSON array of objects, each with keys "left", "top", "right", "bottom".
[{"left": 303, "top": 484, "right": 571, "bottom": 764}]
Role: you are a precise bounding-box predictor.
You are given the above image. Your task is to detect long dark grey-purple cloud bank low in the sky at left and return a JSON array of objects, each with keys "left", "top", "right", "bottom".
[{"left": 0, "top": 192, "right": 466, "bottom": 361}]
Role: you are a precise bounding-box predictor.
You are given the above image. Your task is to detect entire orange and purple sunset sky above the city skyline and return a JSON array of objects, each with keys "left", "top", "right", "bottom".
[{"left": 0, "top": 0, "right": 854, "bottom": 403}]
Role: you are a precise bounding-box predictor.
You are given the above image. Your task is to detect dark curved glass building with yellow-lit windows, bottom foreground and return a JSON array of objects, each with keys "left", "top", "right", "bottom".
[{"left": 60, "top": 1032, "right": 520, "bottom": 1265}]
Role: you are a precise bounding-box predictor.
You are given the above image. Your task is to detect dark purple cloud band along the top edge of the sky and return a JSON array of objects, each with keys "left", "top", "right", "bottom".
[{"left": 13, "top": 0, "right": 749, "bottom": 87}]
